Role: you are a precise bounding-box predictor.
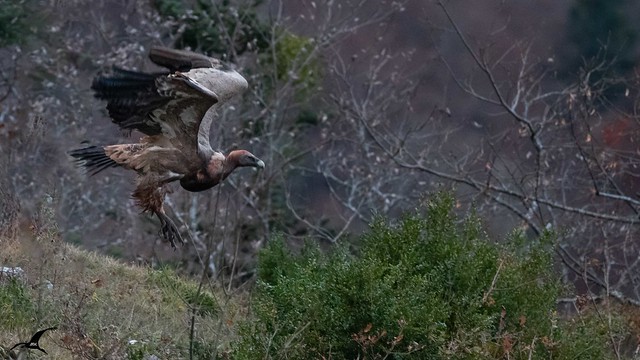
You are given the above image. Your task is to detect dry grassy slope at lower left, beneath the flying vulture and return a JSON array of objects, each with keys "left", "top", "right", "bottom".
[{"left": 0, "top": 217, "right": 241, "bottom": 359}]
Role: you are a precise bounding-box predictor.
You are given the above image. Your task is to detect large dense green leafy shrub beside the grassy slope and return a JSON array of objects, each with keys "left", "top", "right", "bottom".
[{"left": 233, "top": 194, "right": 624, "bottom": 359}]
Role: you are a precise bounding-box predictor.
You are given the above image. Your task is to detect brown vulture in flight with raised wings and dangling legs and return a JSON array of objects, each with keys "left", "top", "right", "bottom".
[{"left": 69, "top": 47, "right": 264, "bottom": 248}]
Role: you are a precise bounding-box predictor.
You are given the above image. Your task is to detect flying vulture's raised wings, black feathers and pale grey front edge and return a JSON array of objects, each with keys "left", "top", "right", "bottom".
[{"left": 91, "top": 47, "right": 247, "bottom": 159}]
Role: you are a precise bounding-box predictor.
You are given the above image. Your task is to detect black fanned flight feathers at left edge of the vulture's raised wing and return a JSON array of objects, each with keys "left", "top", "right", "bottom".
[{"left": 91, "top": 67, "right": 171, "bottom": 135}]
